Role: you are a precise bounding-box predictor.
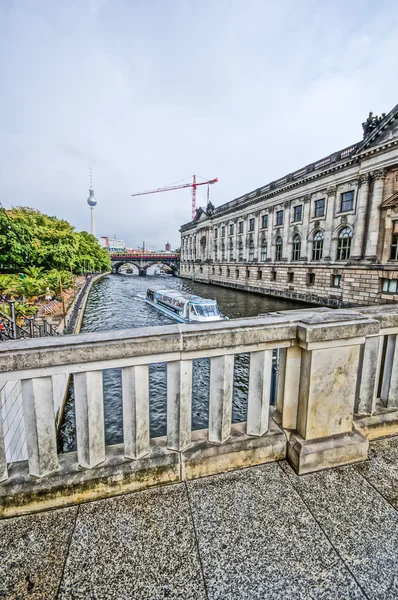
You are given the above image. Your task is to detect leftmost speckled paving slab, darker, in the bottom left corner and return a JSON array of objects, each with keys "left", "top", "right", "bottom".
[{"left": 0, "top": 507, "right": 78, "bottom": 600}]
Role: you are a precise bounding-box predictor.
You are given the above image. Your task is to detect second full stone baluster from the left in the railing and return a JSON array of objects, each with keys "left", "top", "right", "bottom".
[{"left": 73, "top": 371, "right": 105, "bottom": 469}]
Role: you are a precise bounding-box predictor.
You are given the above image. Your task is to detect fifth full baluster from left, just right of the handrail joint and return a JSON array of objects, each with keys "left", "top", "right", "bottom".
[{"left": 209, "top": 354, "right": 234, "bottom": 444}]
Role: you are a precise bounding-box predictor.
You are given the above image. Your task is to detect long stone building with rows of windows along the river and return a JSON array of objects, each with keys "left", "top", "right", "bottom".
[{"left": 180, "top": 105, "right": 398, "bottom": 305}]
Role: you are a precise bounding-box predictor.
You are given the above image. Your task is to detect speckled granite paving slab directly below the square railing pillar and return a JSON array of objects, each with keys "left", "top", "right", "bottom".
[{"left": 283, "top": 463, "right": 398, "bottom": 600}]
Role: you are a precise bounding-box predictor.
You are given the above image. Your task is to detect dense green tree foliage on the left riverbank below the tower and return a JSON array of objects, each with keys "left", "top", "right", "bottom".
[{"left": 0, "top": 207, "right": 110, "bottom": 272}]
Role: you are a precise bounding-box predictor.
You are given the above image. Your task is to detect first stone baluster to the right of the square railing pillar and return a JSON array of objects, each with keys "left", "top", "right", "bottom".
[{"left": 355, "top": 335, "right": 382, "bottom": 415}]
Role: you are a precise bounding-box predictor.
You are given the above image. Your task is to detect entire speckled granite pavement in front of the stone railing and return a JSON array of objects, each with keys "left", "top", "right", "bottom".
[{"left": 0, "top": 437, "right": 398, "bottom": 600}]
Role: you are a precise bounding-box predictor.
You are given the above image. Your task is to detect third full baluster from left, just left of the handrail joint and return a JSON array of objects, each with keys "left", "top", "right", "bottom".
[{"left": 122, "top": 365, "right": 150, "bottom": 459}]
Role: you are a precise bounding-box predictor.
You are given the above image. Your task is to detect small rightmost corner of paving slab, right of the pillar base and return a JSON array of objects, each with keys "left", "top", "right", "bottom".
[{"left": 355, "top": 436, "right": 398, "bottom": 509}]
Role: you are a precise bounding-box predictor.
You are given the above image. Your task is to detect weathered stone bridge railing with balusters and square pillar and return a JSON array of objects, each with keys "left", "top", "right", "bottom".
[{"left": 0, "top": 307, "right": 398, "bottom": 516}]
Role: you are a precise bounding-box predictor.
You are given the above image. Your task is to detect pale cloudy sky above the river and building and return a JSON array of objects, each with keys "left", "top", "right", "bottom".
[{"left": 0, "top": 0, "right": 398, "bottom": 249}]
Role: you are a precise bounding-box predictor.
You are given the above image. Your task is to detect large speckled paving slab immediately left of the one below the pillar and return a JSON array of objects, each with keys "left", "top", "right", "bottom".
[{"left": 188, "top": 463, "right": 365, "bottom": 600}]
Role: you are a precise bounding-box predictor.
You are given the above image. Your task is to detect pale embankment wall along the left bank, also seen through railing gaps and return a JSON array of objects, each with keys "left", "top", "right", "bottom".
[{"left": 0, "top": 273, "right": 109, "bottom": 462}]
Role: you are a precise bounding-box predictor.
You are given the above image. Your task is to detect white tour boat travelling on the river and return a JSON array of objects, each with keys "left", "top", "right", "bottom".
[{"left": 145, "top": 288, "right": 227, "bottom": 323}]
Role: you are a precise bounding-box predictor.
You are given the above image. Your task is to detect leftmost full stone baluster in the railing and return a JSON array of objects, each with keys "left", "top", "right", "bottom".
[{"left": 21, "top": 377, "right": 58, "bottom": 477}]
